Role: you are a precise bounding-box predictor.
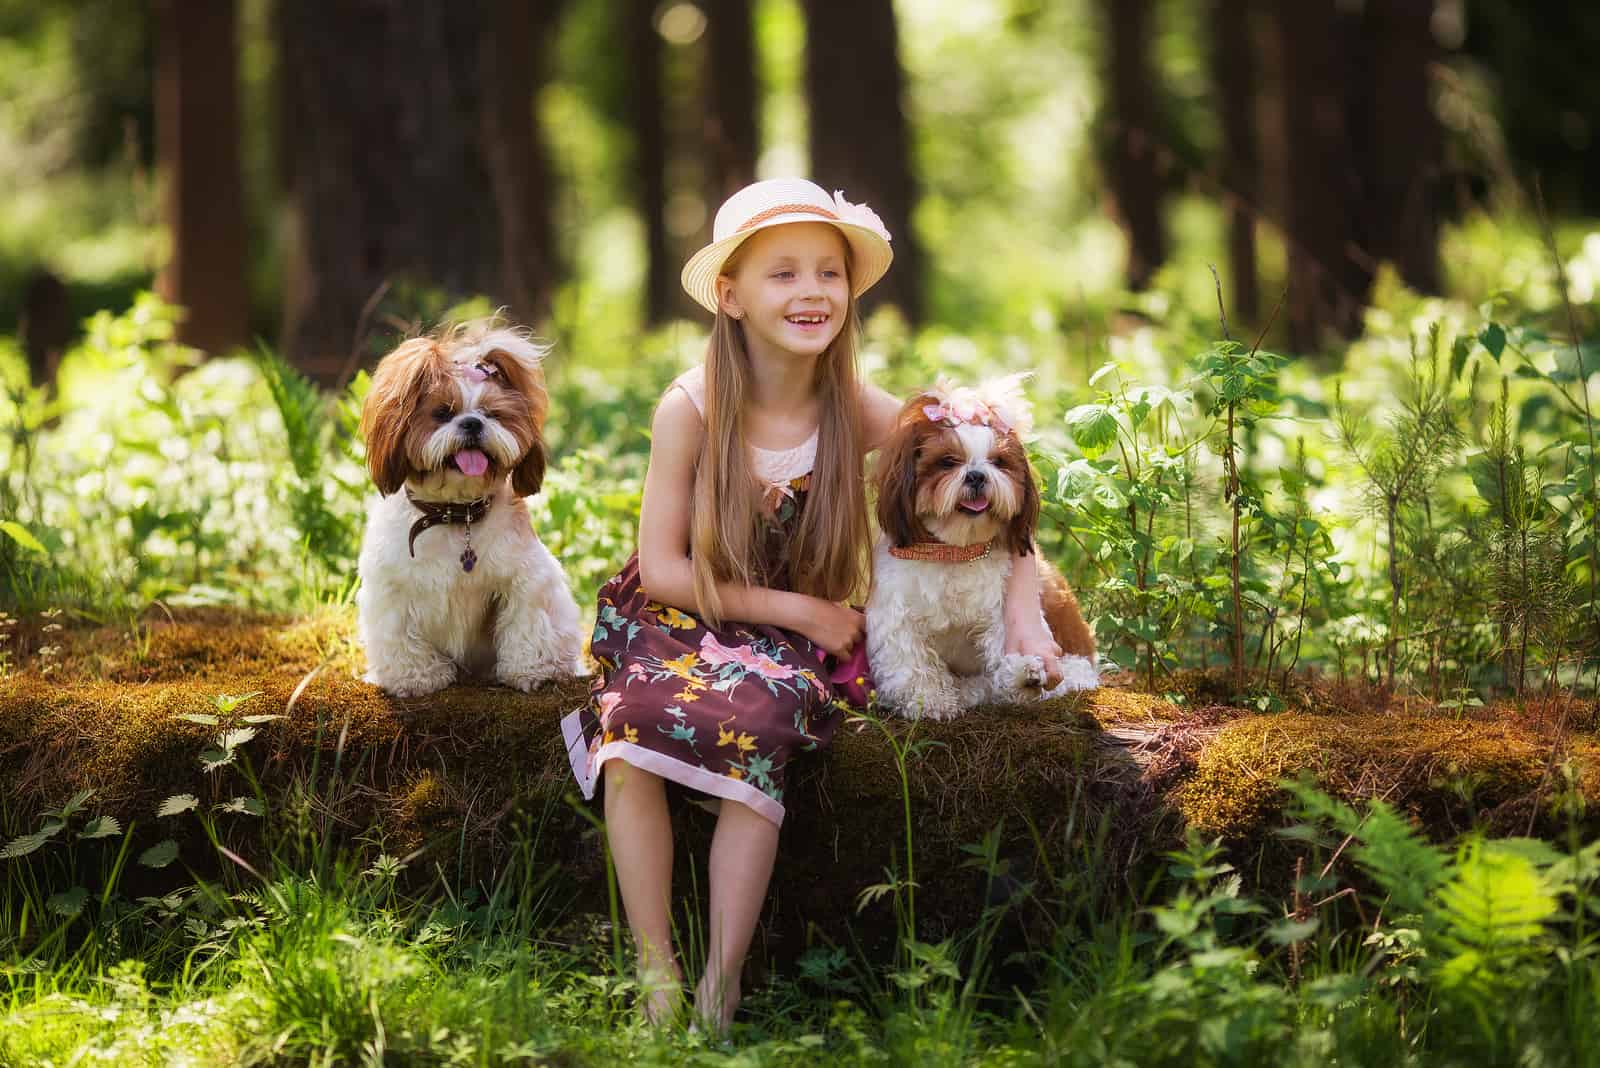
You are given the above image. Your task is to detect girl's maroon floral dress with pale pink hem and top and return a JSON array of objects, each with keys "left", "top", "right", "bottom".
[{"left": 562, "top": 368, "right": 842, "bottom": 825}]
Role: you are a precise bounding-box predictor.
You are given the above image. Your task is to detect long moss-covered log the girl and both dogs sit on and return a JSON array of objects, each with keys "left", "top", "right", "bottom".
[{"left": 0, "top": 614, "right": 1600, "bottom": 958}]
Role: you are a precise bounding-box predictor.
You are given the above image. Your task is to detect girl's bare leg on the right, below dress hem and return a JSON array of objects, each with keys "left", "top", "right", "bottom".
[{"left": 694, "top": 799, "right": 778, "bottom": 1031}]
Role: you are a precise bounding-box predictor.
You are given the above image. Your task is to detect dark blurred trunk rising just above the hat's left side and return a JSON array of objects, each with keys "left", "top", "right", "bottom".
[{"left": 702, "top": 0, "right": 760, "bottom": 211}]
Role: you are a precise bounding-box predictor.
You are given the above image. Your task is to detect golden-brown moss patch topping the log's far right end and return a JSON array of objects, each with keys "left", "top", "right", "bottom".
[{"left": 1173, "top": 713, "right": 1600, "bottom": 838}]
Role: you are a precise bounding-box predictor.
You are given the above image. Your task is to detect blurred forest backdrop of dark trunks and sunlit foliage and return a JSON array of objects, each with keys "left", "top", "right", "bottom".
[{"left": 12, "top": 0, "right": 1600, "bottom": 385}]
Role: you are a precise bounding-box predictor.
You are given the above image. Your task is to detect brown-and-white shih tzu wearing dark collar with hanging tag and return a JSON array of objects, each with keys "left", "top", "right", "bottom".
[{"left": 355, "top": 323, "right": 582, "bottom": 697}]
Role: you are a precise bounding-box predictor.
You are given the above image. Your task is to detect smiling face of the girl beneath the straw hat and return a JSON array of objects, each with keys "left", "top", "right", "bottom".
[{"left": 717, "top": 222, "right": 850, "bottom": 358}]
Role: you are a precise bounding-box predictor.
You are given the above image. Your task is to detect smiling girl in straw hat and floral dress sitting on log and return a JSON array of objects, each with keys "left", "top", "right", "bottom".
[{"left": 562, "top": 179, "right": 1059, "bottom": 1030}]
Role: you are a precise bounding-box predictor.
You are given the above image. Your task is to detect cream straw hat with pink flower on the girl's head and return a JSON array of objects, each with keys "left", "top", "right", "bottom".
[{"left": 683, "top": 177, "right": 894, "bottom": 315}]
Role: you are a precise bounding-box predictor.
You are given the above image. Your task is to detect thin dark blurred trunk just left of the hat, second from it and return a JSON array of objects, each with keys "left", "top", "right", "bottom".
[{"left": 622, "top": 0, "right": 678, "bottom": 326}]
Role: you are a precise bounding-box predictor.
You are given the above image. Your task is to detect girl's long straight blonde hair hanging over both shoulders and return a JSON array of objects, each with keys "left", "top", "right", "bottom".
[{"left": 690, "top": 253, "right": 867, "bottom": 627}]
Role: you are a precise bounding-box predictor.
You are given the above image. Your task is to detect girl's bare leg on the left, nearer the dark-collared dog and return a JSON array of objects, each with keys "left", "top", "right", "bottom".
[{"left": 603, "top": 759, "right": 683, "bottom": 1023}]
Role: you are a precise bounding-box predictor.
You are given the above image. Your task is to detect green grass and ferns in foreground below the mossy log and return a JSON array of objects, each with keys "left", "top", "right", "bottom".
[{"left": 9, "top": 777, "right": 1600, "bottom": 1066}]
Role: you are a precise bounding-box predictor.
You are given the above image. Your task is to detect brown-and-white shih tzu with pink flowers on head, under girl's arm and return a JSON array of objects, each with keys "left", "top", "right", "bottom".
[{"left": 867, "top": 374, "right": 1099, "bottom": 719}]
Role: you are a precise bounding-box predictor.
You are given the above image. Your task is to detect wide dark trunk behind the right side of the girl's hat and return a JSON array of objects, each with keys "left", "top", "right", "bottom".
[{"left": 805, "top": 0, "right": 922, "bottom": 321}]
